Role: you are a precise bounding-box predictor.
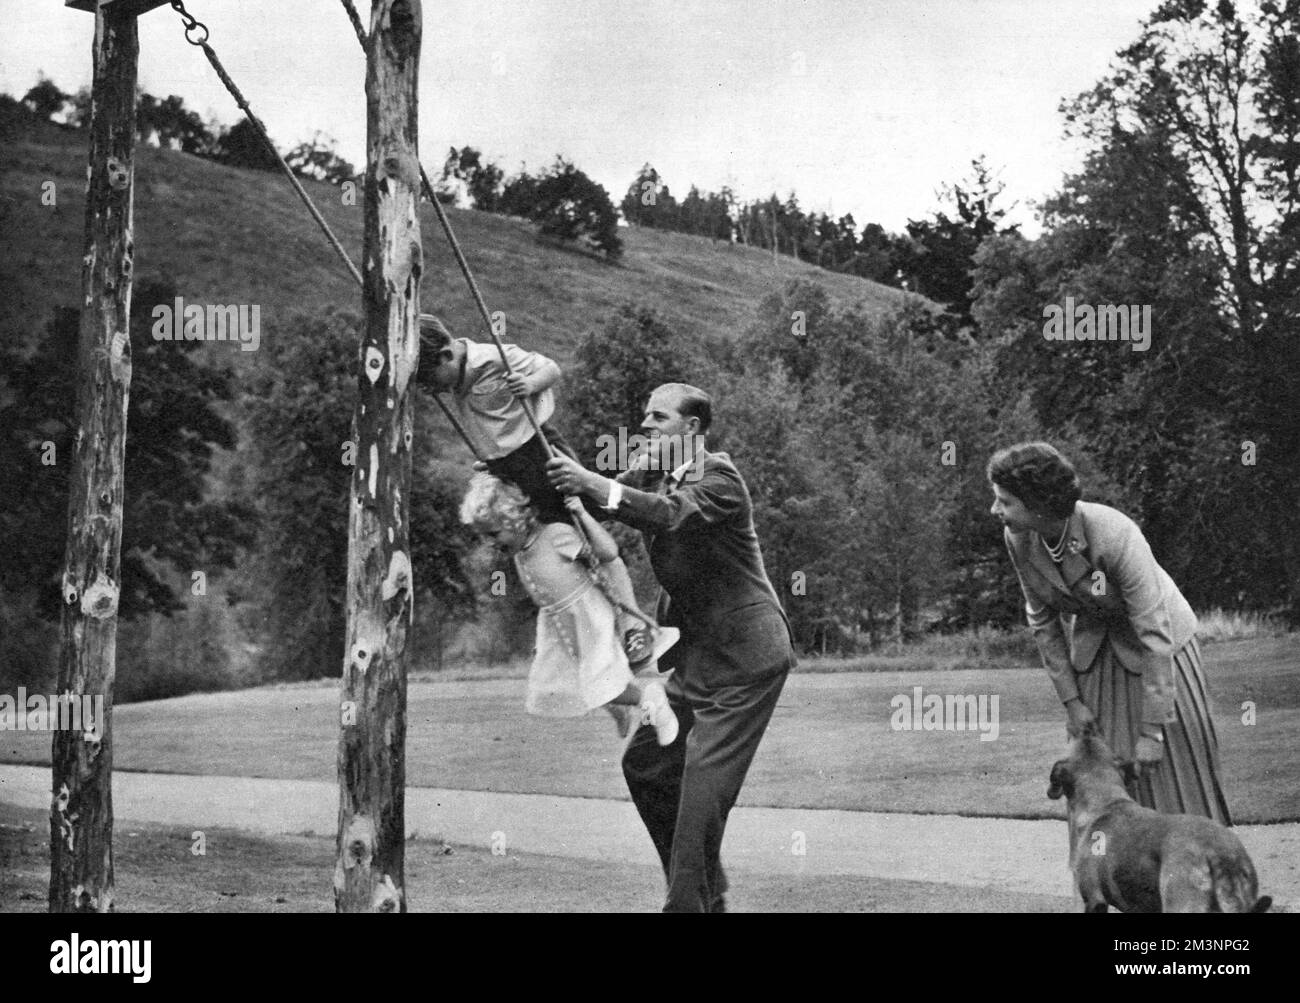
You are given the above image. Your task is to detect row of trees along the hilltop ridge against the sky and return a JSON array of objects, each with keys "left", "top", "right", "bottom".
[{"left": 22, "top": 70, "right": 1015, "bottom": 289}]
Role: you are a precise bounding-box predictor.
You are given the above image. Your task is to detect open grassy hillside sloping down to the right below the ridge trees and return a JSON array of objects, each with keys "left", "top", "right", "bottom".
[{"left": 0, "top": 126, "right": 904, "bottom": 362}]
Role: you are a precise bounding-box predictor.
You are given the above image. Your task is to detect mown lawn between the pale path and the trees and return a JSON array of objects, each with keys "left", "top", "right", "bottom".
[{"left": 0, "top": 635, "right": 1300, "bottom": 822}]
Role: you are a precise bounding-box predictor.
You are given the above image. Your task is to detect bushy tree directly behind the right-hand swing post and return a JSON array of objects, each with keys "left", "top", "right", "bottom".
[{"left": 242, "top": 312, "right": 473, "bottom": 678}]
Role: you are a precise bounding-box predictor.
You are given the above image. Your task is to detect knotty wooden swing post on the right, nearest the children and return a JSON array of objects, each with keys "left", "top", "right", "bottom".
[{"left": 334, "top": 0, "right": 424, "bottom": 912}]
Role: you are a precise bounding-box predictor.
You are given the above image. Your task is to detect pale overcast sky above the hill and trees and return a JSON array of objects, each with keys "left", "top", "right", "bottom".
[{"left": 0, "top": 0, "right": 1156, "bottom": 235}]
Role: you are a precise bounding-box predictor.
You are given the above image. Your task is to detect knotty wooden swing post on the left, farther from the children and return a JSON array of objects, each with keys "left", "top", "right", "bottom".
[{"left": 49, "top": 1, "right": 139, "bottom": 912}]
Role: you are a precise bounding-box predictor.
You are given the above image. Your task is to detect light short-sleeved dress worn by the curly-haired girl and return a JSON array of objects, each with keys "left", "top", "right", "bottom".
[{"left": 515, "top": 522, "right": 632, "bottom": 717}]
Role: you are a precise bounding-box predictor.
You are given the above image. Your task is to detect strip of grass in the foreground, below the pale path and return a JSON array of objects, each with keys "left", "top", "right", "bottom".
[{"left": 0, "top": 804, "right": 1070, "bottom": 913}]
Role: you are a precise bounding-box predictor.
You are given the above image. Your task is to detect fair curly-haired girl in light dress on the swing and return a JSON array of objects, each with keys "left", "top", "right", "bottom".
[{"left": 460, "top": 473, "right": 677, "bottom": 746}]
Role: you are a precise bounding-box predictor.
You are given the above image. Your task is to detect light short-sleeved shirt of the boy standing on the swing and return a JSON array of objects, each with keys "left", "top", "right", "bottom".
[{"left": 451, "top": 338, "right": 555, "bottom": 460}]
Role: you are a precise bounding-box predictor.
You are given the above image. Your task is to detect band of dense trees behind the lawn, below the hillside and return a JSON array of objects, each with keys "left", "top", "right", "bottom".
[{"left": 0, "top": 1, "right": 1300, "bottom": 696}]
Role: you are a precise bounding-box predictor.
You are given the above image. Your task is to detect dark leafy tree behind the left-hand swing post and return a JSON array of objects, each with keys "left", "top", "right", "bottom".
[{"left": 0, "top": 279, "right": 254, "bottom": 621}]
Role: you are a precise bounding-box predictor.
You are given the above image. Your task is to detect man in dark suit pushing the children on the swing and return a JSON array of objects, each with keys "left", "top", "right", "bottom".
[{"left": 547, "top": 383, "right": 796, "bottom": 912}]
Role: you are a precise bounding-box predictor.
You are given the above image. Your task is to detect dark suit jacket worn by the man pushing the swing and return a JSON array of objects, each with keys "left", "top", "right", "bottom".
[{"left": 618, "top": 450, "right": 796, "bottom": 689}]
